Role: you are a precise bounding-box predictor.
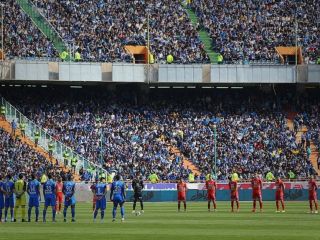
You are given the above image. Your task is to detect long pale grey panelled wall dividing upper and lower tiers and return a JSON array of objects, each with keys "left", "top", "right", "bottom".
[{"left": 0, "top": 61, "right": 320, "bottom": 85}]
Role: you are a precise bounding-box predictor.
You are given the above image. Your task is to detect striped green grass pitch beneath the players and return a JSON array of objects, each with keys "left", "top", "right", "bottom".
[{"left": 0, "top": 202, "right": 320, "bottom": 240}]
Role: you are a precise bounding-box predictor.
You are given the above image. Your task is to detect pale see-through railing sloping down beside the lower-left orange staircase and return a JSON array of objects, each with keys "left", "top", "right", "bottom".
[{"left": 1, "top": 97, "right": 107, "bottom": 173}]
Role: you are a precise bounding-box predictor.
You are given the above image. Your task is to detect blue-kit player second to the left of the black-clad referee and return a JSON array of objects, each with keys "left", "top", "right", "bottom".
[{"left": 93, "top": 177, "right": 107, "bottom": 221}]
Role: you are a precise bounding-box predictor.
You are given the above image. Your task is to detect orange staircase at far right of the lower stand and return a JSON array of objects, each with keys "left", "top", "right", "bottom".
[{"left": 287, "top": 116, "right": 320, "bottom": 176}]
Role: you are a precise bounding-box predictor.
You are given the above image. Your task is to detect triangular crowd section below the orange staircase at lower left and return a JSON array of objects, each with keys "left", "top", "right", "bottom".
[{"left": 0, "top": 128, "right": 67, "bottom": 179}]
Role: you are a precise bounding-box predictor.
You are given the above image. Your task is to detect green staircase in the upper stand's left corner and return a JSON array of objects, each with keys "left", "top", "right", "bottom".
[{"left": 16, "top": 0, "right": 67, "bottom": 57}]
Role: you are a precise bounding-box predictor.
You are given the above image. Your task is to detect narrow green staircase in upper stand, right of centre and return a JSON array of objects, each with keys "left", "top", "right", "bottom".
[{"left": 183, "top": 5, "right": 219, "bottom": 63}]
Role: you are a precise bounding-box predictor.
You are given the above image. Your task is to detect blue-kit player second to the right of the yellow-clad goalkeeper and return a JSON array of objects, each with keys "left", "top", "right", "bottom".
[{"left": 42, "top": 174, "right": 56, "bottom": 222}]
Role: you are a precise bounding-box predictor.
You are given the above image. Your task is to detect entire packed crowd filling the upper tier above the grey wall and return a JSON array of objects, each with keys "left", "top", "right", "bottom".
[{"left": 4, "top": 0, "right": 320, "bottom": 63}]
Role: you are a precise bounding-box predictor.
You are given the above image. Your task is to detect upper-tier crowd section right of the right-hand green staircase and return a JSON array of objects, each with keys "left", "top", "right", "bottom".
[{"left": 190, "top": 0, "right": 320, "bottom": 63}]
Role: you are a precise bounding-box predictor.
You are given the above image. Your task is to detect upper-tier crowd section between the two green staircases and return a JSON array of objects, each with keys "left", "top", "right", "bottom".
[{"left": 33, "top": 0, "right": 208, "bottom": 63}]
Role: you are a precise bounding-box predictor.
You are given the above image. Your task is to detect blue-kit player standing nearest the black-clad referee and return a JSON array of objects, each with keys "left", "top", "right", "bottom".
[{"left": 110, "top": 175, "right": 126, "bottom": 222}]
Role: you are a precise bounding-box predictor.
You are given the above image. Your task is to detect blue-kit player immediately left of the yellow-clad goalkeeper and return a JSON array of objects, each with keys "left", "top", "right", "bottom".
[{"left": 2, "top": 174, "right": 14, "bottom": 222}]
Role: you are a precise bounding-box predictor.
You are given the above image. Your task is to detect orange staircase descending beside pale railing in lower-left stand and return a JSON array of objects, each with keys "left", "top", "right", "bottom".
[{"left": 0, "top": 120, "right": 80, "bottom": 181}]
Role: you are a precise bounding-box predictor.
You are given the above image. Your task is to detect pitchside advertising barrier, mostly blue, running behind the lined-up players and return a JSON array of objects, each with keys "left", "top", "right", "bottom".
[{"left": 68, "top": 182, "right": 316, "bottom": 202}]
